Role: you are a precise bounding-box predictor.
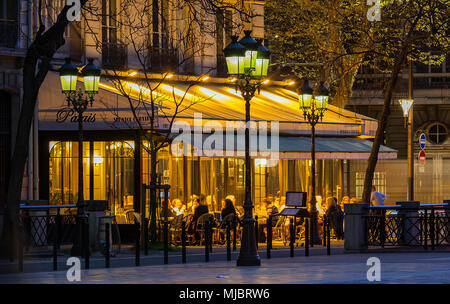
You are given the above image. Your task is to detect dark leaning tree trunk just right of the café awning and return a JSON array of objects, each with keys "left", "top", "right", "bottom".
[{"left": 362, "top": 46, "right": 408, "bottom": 203}]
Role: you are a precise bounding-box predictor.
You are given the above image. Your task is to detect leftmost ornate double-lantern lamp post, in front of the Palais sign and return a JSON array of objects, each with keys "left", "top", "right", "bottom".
[{"left": 59, "top": 58, "right": 100, "bottom": 256}]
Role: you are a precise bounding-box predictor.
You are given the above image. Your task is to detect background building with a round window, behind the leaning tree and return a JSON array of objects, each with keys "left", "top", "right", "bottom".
[{"left": 346, "top": 55, "right": 450, "bottom": 203}]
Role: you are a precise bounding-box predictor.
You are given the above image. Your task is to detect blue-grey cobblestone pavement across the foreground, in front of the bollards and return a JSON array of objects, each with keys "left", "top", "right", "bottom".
[{"left": 0, "top": 252, "right": 450, "bottom": 284}]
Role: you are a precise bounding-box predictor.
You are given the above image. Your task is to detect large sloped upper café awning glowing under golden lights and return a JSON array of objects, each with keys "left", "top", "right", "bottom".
[{"left": 38, "top": 72, "right": 377, "bottom": 137}]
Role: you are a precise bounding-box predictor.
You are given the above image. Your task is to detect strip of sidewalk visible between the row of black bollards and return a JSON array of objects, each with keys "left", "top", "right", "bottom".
[{"left": 0, "top": 241, "right": 344, "bottom": 274}]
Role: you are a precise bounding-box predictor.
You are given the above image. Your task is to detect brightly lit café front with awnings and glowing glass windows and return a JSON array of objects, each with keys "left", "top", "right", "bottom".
[{"left": 39, "top": 75, "right": 396, "bottom": 223}]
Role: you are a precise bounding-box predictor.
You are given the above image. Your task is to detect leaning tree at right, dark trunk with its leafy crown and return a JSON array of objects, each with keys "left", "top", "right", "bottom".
[{"left": 362, "top": 0, "right": 450, "bottom": 202}]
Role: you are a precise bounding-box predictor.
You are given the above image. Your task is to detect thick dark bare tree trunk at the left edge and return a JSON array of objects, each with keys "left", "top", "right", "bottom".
[{"left": 0, "top": 0, "right": 87, "bottom": 256}]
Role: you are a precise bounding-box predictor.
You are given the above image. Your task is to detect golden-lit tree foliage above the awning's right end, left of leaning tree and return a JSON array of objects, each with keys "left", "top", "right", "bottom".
[{"left": 265, "top": 0, "right": 370, "bottom": 107}]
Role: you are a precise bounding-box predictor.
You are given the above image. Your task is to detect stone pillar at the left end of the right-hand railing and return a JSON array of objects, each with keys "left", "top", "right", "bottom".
[{"left": 344, "top": 203, "right": 369, "bottom": 252}]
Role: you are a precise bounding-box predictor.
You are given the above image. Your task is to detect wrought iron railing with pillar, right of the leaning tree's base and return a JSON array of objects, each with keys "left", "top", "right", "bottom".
[{"left": 365, "top": 204, "right": 450, "bottom": 249}]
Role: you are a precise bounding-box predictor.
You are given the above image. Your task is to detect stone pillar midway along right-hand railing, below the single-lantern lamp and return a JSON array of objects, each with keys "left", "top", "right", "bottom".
[{"left": 397, "top": 201, "right": 420, "bottom": 246}]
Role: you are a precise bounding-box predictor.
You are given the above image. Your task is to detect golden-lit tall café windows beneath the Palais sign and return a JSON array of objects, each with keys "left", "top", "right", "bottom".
[{"left": 49, "top": 141, "right": 134, "bottom": 214}]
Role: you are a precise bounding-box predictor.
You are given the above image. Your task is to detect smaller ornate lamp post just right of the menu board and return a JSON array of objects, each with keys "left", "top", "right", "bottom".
[{"left": 298, "top": 80, "right": 329, "bottom": 244}]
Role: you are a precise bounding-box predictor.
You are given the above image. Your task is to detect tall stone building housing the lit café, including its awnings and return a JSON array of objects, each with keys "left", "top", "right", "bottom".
[{"left": 0, "top": 0, "right": 397, "bottom": 222}]
